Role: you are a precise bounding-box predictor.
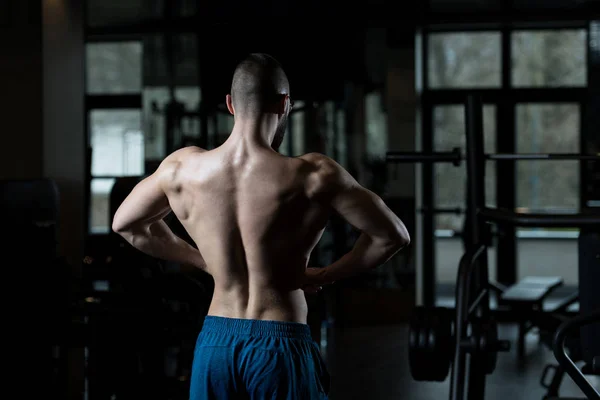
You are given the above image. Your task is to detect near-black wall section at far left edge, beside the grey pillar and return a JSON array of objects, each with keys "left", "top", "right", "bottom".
[{"left": 0, "top": 0, "right": 43, "bottom": 179}]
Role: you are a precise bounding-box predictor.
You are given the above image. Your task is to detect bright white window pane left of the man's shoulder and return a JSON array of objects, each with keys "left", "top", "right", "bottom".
[{"left": 90, "top": 110, "right": 144, "bottom": 176}]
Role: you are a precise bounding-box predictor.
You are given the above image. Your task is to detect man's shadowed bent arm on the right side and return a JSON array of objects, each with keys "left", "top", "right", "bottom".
[{"left": 308, "top": 155, "right": 410, "bottom": 284}]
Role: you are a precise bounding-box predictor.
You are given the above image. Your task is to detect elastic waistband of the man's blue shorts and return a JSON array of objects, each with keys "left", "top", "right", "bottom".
[{"left": 202, "top": 315, "right": 312, "bottom": 340}]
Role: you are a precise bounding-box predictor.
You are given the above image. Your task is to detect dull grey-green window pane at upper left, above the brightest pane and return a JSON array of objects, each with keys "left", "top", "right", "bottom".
[{"left": 86, "top": 42, "right": 142, "bottom": 94}]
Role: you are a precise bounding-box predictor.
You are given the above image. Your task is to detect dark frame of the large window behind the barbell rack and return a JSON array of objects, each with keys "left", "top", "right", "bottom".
[{"left": 416, "top": 21, "right": 589, "bottom": 306}]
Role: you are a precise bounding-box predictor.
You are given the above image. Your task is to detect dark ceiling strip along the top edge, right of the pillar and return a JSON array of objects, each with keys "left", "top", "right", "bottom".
[{"left": 87, "top": 0, "right": 600, "bottom": 30}]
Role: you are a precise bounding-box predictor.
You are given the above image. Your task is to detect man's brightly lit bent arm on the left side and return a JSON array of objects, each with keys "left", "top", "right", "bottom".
[{"left": 112, "top": 154, "right": 206, "bottom": 269}]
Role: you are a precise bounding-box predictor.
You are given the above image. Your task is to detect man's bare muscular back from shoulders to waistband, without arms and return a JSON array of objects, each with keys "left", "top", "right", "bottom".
[{"left": 163, "top": 147, "right": 329, "bottom": 323}]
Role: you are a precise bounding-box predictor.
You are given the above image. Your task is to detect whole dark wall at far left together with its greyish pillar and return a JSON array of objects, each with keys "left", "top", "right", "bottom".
[{"left": 0, "top": 0, "right": 85, "bottom": 265}]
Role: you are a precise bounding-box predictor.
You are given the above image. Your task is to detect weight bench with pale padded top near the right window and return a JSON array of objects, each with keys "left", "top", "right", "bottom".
[{"left": 499, "top": 276, "right": 563, "bottom": 359}]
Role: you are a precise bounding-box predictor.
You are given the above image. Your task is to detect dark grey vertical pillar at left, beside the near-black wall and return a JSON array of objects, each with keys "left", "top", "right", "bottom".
[{"left": 38, "top": 0, "right": 86, "bottom": 268}]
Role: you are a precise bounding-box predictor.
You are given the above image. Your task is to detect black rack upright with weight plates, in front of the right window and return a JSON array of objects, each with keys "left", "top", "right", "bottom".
[{"left": 409, "top": 95, "right": 600, "bottom": 400}]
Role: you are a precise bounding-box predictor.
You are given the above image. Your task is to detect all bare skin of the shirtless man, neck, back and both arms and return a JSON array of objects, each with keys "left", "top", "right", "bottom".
[{"left": 113, "top": 94, "right": 410, "bottom": 323}]
